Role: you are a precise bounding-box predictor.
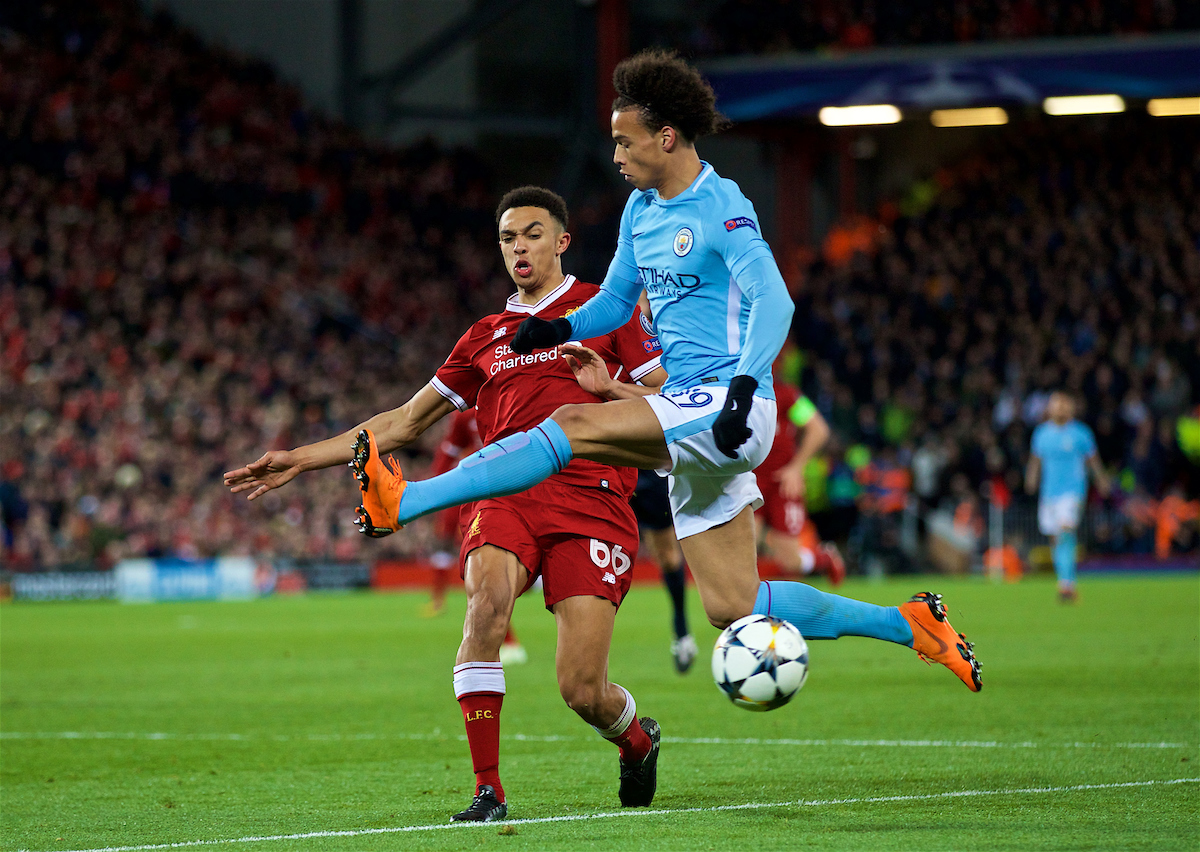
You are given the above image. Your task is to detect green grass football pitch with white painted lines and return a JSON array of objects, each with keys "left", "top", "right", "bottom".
[{"left": 0, "top": 575, "right": 1200, "bottom": 852}]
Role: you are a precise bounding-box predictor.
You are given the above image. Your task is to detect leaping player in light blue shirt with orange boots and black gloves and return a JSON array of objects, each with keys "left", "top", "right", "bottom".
[{"left": 333, "top": 50, "right": 980, "bottom": 705}]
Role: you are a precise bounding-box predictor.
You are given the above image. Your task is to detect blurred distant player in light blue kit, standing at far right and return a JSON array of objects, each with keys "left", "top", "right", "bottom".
[{"left": 1025, "top": 392, "right": 1109, "bottom": 602}]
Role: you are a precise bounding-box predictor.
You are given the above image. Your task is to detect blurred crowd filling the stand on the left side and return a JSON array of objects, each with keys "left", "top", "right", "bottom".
[{"left": 0, "top": 0, "right": 510, "bottom": 569}]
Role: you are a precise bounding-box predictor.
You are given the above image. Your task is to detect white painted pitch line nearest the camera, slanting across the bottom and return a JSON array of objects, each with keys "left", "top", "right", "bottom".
[{"left": 19, "top": 778, "right": 1200, "bottom": 852}]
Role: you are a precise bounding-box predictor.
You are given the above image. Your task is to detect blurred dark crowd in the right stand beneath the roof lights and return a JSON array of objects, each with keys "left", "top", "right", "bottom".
[{"left": 796, "top": 119, "right": 1200, "bottom": 564}]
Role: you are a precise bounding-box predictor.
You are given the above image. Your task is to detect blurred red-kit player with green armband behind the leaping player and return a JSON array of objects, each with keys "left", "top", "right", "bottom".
[{"left": 755, "top": 361, "right": 846, "bottom": 586}]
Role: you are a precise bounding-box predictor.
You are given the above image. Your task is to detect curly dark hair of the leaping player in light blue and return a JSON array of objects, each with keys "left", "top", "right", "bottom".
[{"left": 612, "top": 48, "right": 730, "bottom": 142}]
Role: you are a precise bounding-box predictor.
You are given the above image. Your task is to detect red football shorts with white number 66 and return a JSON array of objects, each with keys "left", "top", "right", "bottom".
[{"left": 458, "top": 480, "right": 637, "bottom": 610}]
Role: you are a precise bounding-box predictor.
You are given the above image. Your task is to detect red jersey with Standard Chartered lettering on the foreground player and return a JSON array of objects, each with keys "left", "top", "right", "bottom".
[{"left": 431, "top": 275, "right": 662, "bottom": 497}]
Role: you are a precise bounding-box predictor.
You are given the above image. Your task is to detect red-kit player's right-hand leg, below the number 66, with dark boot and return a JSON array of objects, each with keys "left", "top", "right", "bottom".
[{"left": 554, "top": 595, "right": 661, "bottom": 808}]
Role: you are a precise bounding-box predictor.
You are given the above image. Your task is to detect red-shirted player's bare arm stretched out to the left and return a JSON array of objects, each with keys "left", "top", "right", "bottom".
[{"left": 224, "top": 384, "right": 454, "bottom": 500}]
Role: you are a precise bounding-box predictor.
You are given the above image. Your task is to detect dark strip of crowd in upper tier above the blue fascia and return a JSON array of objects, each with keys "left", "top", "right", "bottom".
[{"left": 688, "top": 0, "right": 1200, "bottom": 55}]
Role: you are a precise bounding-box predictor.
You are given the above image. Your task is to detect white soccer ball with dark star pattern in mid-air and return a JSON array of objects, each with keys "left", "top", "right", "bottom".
[{"left": 713, "top": 616, "right": 809, "bottom": 710}]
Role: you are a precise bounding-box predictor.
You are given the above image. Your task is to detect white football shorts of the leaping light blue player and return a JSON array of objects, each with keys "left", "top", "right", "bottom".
[{"left": 644, "top": 385, "right": 775, "bottom": 539}]
